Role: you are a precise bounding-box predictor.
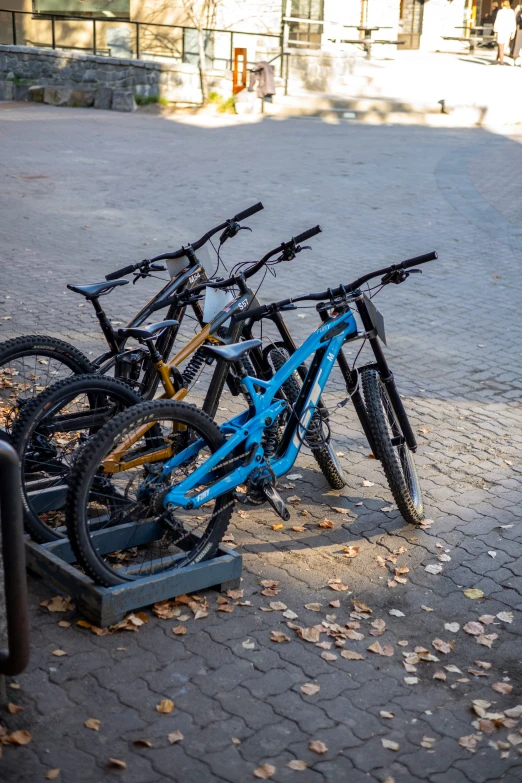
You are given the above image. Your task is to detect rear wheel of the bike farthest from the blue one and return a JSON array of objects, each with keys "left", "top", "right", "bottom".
[{"left": 0, "top": 335, "right": 92, "bottom": 432}]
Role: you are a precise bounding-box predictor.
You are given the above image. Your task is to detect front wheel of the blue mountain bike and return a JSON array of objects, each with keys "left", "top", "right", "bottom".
[{"left": 361, "top": 369, "right": 423, "bottom": 525}]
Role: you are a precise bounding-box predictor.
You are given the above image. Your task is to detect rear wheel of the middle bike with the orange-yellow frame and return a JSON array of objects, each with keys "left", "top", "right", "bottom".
[{"left": 12, "top": 373, "right": 142, "bottom": 543}]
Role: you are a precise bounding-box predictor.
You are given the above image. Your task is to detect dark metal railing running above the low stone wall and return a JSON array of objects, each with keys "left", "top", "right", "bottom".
[{"left": 0, "top": 9, "right": 282, "bottom": 69}]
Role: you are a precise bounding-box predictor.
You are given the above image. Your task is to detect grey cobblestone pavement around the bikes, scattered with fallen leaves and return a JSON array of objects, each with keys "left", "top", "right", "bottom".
[{"left": 0, "top": 105, "right": 522, "bottom": 783}]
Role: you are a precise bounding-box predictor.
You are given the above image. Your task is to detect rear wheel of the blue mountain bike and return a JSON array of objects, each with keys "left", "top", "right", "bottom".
[{"left": 66, "top": 400, "right": 234, "bottom": 586}]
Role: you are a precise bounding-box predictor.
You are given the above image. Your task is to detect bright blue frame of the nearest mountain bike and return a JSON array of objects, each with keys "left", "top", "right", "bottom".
[{"left": 158, "top": 310, "right": 357, "bottom": 509}]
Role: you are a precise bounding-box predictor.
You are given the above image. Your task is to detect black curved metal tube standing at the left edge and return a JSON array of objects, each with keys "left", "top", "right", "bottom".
[{"left": 0, "top": 438, "right": 29, "bottom": 676}]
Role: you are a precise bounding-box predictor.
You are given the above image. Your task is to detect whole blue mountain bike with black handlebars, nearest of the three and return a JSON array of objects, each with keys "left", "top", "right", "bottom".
[{"left": 66, "top": 248, "right": 437, "bottom": 585}]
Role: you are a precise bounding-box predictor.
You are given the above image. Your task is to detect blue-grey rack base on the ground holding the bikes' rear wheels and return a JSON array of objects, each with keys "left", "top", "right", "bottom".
[{"left": 25, "top": 538, "right": 243, "bottom": 628}]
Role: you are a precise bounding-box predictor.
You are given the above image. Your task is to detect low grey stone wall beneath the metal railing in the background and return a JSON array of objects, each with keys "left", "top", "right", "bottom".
[{"left": 0, "top": 46, "right": 232, "bottom": 110}]
